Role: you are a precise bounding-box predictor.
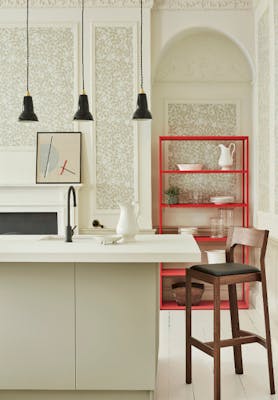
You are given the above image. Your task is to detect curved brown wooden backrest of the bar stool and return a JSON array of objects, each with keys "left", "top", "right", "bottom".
[{"left": 226, "top": 226, "right": 269, "bottom": 271}]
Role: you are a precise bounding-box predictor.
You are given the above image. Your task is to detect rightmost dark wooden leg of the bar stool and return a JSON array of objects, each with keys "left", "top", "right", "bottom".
[{"left": 262, "top": 272, "right": 275, "bottom": 394}]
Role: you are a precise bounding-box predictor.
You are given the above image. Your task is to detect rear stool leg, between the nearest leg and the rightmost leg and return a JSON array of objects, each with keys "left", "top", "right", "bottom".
[{"left": 228, "top": 285, "right": 243, "bottom": 374}]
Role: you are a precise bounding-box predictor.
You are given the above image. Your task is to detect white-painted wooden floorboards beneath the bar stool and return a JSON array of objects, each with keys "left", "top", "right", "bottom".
[{"left": 156, "top": 310, "right": 278, "bottom": 400}]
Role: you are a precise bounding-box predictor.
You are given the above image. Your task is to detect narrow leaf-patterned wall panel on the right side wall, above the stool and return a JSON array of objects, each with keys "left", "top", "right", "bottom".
[{"left": 257, "top": 9, "right": 270, "bottom": 212}]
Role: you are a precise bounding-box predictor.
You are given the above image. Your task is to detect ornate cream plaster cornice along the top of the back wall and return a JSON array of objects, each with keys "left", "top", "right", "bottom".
[{"left": 0, "top": 0, "right": 253, "bottom": 10}]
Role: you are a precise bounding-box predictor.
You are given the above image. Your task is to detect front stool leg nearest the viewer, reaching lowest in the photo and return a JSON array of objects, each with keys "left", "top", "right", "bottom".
[{"left": 213, "top": 279, "right": 221, "bottom": 400}]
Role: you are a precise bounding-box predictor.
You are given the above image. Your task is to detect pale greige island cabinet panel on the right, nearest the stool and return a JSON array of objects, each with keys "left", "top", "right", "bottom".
[{"left": 76, "top": 263, "right": 158, "bottom": 390}]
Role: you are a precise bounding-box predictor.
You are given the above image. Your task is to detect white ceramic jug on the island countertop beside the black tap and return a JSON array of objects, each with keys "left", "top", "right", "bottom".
[{"left": 116, "top": 203, "right": 139, "bottom": 242}]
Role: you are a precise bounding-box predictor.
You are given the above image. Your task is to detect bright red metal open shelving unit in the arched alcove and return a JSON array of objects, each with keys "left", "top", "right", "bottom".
[{"left": 159, "top": 136, "right": 249, "bottom": 310}]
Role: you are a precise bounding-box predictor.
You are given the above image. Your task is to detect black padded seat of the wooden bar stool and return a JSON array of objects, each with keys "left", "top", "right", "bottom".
[{"left": 191, "top": 263, "right": 260, "bottom": 276}]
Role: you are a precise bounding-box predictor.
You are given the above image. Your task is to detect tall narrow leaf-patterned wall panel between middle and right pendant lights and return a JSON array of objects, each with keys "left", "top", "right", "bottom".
[{"left": 95, "top": 26, "right": 135, "bottom": 209}]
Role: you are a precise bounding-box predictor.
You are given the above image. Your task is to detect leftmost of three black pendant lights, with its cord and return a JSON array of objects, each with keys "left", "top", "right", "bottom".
[{"left": 18, "top": 0, "right": 38, "bottom": 122}]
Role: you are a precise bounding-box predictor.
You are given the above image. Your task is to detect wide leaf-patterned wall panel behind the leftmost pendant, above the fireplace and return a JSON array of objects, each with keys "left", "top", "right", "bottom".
[{"left": 0, "top": 26, "right": 74, "bottom": 147}]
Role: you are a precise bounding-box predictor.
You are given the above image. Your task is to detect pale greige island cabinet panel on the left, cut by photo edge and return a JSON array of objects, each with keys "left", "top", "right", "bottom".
[{"left": 0, "top": 263, "right": 75, "bottom": 389}]
